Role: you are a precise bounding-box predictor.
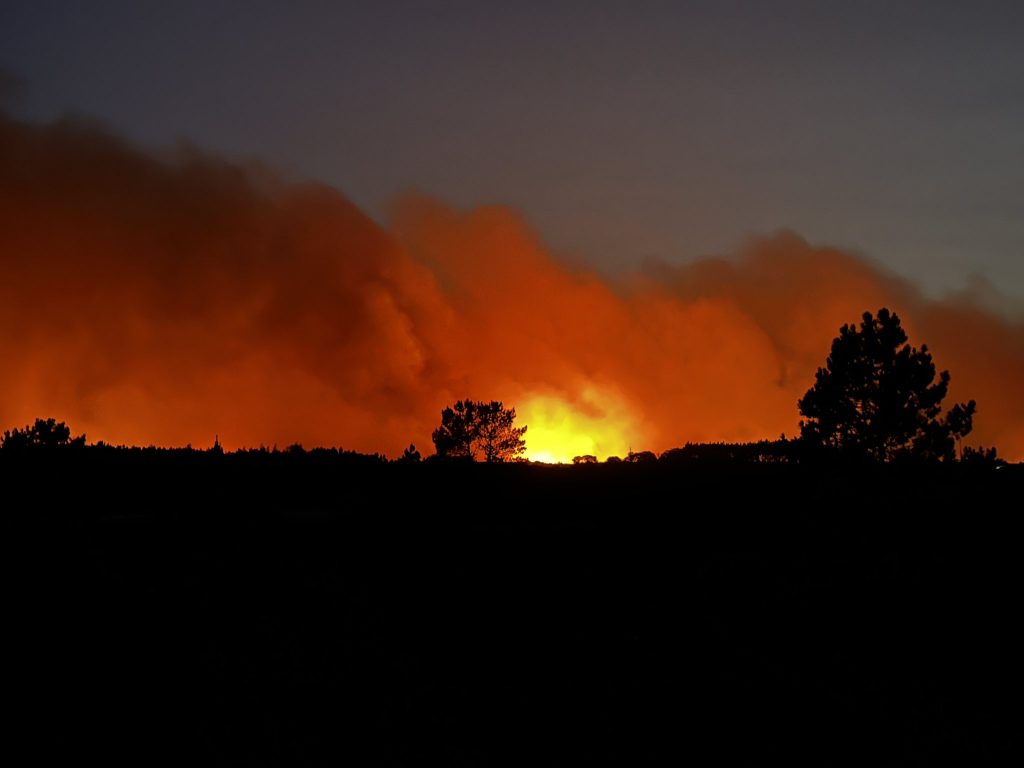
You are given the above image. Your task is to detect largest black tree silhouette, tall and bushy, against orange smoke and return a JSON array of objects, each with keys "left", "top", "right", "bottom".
[{"left": 798, "top": 308, "right": 975, "bottom": 461}]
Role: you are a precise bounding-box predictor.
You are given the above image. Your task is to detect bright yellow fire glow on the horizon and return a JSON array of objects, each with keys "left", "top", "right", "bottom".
[{"left": 516, "top": 388, "right": 635, "bottom": 464}]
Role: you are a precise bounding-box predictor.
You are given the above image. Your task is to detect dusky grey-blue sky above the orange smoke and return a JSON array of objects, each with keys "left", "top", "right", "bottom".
[{"left": 6, "top": 0, "right": 1024, "bottom": 299}]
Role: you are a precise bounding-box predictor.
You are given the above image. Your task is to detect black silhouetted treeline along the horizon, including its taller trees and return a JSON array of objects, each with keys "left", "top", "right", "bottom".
[{"left": 0, "top": 307, "right": 1004, "bottom": 466}]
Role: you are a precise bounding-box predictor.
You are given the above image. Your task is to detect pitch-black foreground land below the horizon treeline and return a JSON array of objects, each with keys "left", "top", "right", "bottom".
[{"left": 0, "top": 453, "right": 1024, "bottom": 766}]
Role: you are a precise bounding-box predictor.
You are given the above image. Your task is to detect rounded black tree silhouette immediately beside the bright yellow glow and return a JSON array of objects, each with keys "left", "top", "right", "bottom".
[{"left": 431, "top": 399, "right": 526, "bottom": 463}]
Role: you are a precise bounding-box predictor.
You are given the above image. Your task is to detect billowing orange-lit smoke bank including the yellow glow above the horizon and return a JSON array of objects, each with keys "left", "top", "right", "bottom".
[{"left": 0, "top": 112, "right": 1024, "bottom": 458}]
